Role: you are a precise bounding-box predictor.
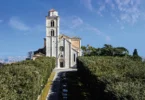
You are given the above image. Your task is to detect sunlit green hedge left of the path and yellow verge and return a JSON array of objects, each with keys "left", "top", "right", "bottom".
[{"left": 0, "top": 57, "right": 55, "bottom": 100}]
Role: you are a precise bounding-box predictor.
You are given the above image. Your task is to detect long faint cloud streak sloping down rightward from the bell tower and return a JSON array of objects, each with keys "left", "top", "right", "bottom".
[{"left": 60, "top": 16, "right": 111, "bottom": 41}]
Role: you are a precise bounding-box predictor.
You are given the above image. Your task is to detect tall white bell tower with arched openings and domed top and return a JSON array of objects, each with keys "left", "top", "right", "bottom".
[{"left": 46, "top": 9, "right": 60, "bottom": 67}]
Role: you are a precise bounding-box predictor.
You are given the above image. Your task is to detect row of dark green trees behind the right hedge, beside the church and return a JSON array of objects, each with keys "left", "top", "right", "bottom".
[{"left": 81, "top": 44, "right": 142, "bottom": 61}]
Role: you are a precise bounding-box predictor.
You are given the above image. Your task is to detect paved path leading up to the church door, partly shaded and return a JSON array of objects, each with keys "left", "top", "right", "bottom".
[{"left": 47, "top": 69, "right": 77, "bottom": 100}]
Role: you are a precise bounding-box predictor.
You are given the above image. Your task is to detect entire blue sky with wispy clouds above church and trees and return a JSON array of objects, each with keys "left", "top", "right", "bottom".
[{"left": 0, "top": 0, "right": 145, "bottom": 58}]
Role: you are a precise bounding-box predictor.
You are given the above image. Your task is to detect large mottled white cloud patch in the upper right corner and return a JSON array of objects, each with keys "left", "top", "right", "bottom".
[{"left": 97, "top": 0, "right": 143, "bottom": 24}]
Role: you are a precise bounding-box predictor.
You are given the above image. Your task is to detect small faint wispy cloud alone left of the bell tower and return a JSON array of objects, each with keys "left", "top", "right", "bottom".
[{"left": 9, "top": 17, "right": 30, "bottom": 31}]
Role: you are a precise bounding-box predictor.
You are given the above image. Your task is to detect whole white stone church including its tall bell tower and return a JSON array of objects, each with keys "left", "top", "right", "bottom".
[{"left": 44, "top": 9, "right": 81, "bottom": 68}]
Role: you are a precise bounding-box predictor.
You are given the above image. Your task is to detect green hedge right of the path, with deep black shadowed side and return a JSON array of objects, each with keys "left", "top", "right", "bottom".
[{"left": 77, "top": 56, "right": 145, "bottom": 100}]
